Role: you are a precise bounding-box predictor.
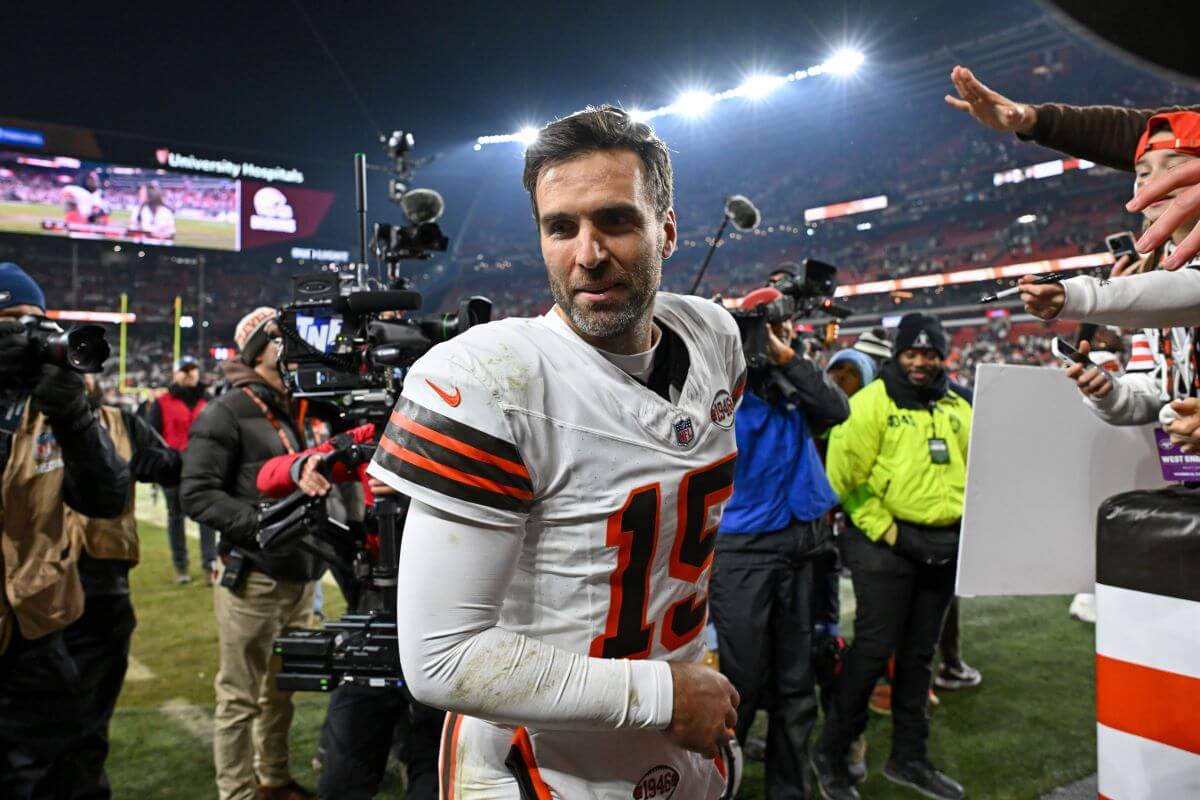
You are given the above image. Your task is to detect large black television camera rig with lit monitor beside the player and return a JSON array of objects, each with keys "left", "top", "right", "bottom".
[{"left": 272, "top": 131, "right": 492, "bottom": 691}]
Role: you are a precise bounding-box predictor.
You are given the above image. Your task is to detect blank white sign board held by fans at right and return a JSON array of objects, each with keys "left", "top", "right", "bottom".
[{"left": 958, "top": 365, "right": 1166, "bottom": 596}]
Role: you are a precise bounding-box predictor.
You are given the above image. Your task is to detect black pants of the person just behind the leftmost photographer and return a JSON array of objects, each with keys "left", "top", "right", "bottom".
[{"left": 62, "top": 595, "right": 137, "bottom": 800}]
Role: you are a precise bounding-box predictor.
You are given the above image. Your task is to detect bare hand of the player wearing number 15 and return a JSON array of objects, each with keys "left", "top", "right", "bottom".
[{"left": 667, "top": 662, "right": 742, "bottom": 758}]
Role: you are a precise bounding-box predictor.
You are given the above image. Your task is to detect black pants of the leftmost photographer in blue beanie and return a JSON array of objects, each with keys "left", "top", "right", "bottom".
[{"left": 0, "top": 622, "right": 83, "bottom": 800}]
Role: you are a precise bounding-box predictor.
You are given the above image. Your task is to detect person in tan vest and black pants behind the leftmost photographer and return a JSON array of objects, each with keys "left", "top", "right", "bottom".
[{"left": 64, "top": 375, "right": 181, "bottom": 800}]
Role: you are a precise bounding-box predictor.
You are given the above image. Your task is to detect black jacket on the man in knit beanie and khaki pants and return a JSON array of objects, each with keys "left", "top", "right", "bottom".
[{"left": 180, "top": 361, "right": 317, "bottom": 581}]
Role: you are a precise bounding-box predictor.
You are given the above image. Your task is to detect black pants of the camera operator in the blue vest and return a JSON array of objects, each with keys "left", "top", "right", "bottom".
[{"left": 709, "top": 522, "right": 823, "bottom": 800}]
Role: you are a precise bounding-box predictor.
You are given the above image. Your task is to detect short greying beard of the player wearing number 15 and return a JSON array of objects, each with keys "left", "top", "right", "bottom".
[{"left": 548, "top": 235, "right": 662, "bottom": 339}]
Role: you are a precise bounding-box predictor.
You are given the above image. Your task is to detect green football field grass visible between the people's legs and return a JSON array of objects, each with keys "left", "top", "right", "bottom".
[{"left": 108, "top": 487, "right": 1096, "bottom": 800}]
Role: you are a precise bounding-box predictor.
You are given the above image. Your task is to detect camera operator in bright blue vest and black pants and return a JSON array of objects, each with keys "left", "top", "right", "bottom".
[{"left": 709, "top": 288, "right": 850, "bottom": 799}]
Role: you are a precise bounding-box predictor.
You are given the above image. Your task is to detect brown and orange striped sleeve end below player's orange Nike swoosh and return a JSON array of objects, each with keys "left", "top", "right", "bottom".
[{"left": 376, "top": 397, "right": 533, "bottom": 511}]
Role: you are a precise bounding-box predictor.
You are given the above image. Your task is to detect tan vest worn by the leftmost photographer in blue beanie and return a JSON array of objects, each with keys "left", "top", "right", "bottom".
[{"left": 0, "top": 405, "right": 83, "bottom": 644}]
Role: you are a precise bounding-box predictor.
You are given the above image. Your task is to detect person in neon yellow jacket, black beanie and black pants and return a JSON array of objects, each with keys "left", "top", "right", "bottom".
[{"left": 812, "top": 313, "right": 971, "bottom": 800}]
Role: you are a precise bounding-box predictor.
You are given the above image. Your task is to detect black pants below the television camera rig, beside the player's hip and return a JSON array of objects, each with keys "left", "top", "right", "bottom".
[{"left": 317, "top": 686, "right": 445, "bottom": 800}]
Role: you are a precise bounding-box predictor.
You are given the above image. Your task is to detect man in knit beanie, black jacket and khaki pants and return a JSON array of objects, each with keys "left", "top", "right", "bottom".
[{"left": 180, "top": 307, "right": 319, "bottom": 800}]
